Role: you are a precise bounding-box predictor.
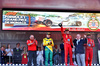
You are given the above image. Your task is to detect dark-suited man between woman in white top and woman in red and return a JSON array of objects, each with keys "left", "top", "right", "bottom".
[{"left": 13, "top": 43, "right": 22, "bottom": 64}]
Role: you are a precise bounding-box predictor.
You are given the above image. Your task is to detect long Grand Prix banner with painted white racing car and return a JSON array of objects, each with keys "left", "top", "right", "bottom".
[{"left": 2, "top": 9, "right": 100, "bottom": 31}]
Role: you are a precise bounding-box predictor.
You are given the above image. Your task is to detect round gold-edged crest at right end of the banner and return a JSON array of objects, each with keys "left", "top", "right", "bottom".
[{"left": 87, "top": 16, "right": 99, "bottom": 30}]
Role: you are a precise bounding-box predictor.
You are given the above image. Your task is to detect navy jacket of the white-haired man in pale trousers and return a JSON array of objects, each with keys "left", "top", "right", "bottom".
[{"left": 73, "top": 39, "right": 87, "bottom": 54}]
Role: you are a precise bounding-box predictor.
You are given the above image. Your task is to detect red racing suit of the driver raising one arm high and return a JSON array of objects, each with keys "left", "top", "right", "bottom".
[{"left": 61, "top": 27, "right": 73, "bottom": 65}]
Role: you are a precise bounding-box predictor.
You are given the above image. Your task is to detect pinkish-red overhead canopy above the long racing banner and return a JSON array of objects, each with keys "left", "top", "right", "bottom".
[{"left": 0, "top": 0, "right": 100, "bottom": 10}]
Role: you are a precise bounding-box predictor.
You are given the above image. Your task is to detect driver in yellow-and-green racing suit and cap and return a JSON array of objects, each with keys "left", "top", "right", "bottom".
[{"left": 43, "top": 32, "right": 54, "bottom": 66}]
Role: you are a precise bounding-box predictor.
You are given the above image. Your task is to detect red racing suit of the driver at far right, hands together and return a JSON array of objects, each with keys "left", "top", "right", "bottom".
[{"left": 85, "top": 38, "right": 95, "bottom": 66}]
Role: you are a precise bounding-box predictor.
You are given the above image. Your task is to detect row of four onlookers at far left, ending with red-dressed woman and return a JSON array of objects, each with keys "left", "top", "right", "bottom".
[{"left": 0, "top": 43, "right": 28, "bottom": 64}]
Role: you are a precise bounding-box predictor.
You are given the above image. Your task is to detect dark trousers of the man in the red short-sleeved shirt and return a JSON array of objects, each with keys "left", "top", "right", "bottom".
[{"left": 28, "top": 51, "right": 37, "bottom": 66}]
